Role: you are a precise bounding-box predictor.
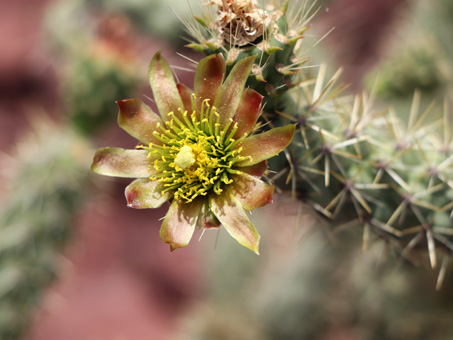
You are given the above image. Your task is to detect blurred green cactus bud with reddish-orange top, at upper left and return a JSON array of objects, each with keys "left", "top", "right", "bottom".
[{"left": 63, "top": 15, "right": 140, "bottom": 135}]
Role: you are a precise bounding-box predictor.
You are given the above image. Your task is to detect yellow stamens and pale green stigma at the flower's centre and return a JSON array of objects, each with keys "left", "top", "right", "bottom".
[{"left": 144, "top": 101, "right": 251, "bottom": 203}]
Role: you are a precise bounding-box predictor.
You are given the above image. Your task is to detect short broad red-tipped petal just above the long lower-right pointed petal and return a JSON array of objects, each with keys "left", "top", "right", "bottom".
[{"left": 228, "top": 174, "right": 274, "bottom": 211}]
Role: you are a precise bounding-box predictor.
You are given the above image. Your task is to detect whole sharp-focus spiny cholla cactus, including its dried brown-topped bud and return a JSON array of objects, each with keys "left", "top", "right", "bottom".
[{"left": 177, "top": 0, "right": 453, "bottom": 276}]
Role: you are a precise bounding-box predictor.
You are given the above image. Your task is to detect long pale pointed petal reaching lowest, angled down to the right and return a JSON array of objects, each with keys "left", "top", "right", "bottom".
[{"left": 209, "top": 194, "right": 260, "bottom": 255}]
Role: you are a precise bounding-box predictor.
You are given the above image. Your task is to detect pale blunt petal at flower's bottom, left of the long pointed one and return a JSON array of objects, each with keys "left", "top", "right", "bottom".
[{"left": 160, "top": 200, "right": 203, "bottom": 251}]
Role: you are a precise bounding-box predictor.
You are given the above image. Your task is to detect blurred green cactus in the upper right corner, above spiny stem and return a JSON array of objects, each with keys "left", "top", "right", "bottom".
[{"left": 367, "top": 1, "right": 453, "bottom": 100}]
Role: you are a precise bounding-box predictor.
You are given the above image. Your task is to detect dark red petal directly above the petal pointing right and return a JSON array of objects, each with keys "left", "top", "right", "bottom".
[{"left": 233, "top": 89, "right": 263, "bottom": 139}]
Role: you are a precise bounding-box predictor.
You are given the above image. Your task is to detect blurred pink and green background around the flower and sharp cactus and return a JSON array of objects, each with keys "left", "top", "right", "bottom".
[{"left": 0, "top": 0, "right": 453, "bottom": 340}]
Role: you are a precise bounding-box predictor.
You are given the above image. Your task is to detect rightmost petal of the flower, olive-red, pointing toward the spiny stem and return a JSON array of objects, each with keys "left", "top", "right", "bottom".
[{"left": 238, "top": 124, "right": 296, "bottom": 166}]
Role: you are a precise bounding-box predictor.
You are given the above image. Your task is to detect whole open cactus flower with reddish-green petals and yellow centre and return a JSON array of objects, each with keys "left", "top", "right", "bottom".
[{"left": 92, "top": 52, "right": 295, "bottom": 254}]
